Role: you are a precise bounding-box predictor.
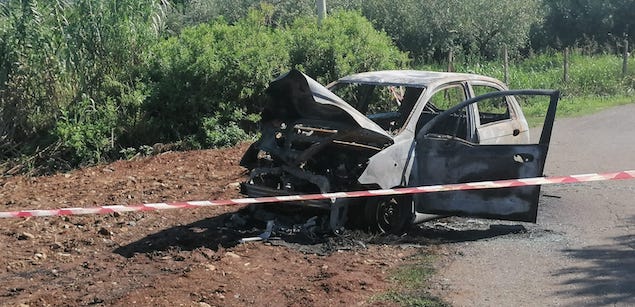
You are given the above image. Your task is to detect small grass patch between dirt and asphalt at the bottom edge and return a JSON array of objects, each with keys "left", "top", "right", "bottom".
[{"left": 372, "top": 254, "right": 449, "bottom": 307}]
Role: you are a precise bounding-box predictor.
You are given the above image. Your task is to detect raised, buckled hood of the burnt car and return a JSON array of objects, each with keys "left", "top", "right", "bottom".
[{"left": 262, "top": 69, "right": 392, "bottom": 140}]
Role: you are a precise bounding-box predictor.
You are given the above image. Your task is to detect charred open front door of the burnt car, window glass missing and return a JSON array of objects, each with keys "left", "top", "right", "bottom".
[{"left": 409, "top": 90, "right": 560, "bottom": 223}]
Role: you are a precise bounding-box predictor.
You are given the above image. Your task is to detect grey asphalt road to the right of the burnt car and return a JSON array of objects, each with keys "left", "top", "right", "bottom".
[{"left": 435, "top": 104, "right": 635, "bottom": 306}]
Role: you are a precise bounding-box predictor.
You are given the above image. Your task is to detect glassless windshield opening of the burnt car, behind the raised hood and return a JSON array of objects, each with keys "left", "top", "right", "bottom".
[{"left": 329, "top": 83, "right": 424, "bottom": 132}]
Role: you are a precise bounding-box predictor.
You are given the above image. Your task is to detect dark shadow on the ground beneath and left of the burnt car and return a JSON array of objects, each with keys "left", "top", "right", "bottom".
[{"left": 114, "top": 212, "right": 526, "bottom": 257}]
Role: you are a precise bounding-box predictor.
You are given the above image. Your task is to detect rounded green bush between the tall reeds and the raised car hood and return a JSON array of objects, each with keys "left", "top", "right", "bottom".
[{"left": 144, "top": 11, "right": 289, "bottom": 145}]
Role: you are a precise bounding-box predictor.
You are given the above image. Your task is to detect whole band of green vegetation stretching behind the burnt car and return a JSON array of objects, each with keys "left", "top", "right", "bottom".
[{"left": 0, "top": 0, "right": 635, "bottom": 171}]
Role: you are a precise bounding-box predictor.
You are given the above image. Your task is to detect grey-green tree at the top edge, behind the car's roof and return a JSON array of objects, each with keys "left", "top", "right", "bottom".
[{"left": 362, "top": 0, "right": 542, "bottom": 60}]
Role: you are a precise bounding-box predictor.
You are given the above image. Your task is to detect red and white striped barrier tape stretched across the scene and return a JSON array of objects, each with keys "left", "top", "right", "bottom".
[{"left": 0, "top": 170, "right": 635, "bottom": 218}]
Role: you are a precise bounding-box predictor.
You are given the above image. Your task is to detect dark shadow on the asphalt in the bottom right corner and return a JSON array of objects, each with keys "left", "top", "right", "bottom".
[{"left": 556, "top": 217, "right": 635, "bottom": 306}]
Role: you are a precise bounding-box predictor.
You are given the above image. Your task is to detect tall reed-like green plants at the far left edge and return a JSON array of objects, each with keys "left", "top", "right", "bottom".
[{"left": 0, "top": 0, "right": 166, "bottom": 168}]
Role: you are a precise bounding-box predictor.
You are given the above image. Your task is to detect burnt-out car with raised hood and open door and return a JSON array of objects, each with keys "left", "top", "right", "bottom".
[{"left": 241, "top": 70, "right": 559, "bottom": 232}]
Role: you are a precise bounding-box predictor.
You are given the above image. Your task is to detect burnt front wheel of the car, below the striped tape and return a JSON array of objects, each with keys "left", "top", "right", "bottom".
[{"left": 364, "top": 196, "right": 414, "bottom": 235}]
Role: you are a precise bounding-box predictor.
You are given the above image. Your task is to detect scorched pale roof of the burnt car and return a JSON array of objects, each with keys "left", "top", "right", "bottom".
[{"left": 334, "top": 70, "right": 501, "bottom": 87}]
